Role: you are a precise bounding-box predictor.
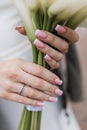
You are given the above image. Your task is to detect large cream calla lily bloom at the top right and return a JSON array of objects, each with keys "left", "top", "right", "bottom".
[{"left": 48, "top": 0, "right": 87, "bottom": 17}]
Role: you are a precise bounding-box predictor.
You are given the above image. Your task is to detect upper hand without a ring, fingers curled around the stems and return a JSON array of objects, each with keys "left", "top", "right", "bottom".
[{"left": 16, "top": 25, "right": 79, "bottom": 69}]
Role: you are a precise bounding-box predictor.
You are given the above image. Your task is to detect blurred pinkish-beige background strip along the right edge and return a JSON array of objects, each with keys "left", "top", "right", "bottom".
[{"left": 72, "top": 28, "right": 87, "bottom": 130}]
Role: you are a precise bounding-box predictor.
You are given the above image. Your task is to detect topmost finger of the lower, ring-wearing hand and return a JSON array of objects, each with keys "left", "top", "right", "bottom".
[{"left": 18, "top": 60, "right": 62, "bottom": 85}]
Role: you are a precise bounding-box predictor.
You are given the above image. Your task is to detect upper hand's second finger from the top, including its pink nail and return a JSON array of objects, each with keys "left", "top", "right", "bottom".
[{"left": 35, "top": 30, "right": 69, "bottom": 54}]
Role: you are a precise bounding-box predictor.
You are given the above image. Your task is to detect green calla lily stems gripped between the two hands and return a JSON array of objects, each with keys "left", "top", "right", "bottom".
[{"left": 19, "top": 6, "right": 51, "bottom": 130}]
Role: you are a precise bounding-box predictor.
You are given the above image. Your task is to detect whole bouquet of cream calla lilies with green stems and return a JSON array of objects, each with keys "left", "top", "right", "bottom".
[{"left": 14, "top": 0, "right": 87, "bottom": 130}]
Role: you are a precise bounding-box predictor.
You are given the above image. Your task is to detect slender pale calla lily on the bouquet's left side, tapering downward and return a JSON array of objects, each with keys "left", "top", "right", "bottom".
[{"left": 14, "top": 0, "right": 35, "bottom": 42}]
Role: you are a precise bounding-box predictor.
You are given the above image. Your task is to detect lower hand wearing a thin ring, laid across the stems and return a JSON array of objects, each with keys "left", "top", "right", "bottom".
[{"left": 0, "top": 59, "right": 62, "bottom": 106}]
